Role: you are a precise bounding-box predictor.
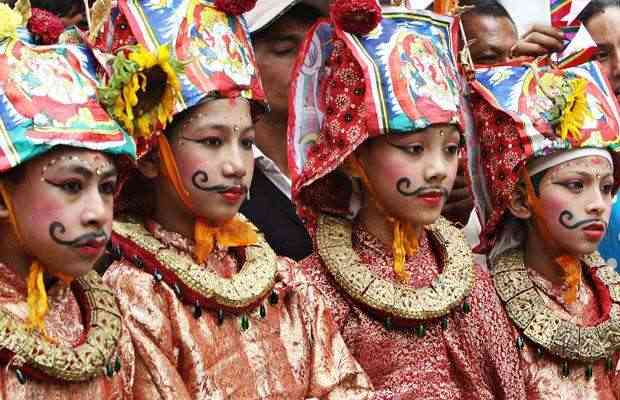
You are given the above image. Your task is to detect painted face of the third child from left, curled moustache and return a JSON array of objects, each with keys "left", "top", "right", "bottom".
[{"left": 359, "top": 125, "right": 460, "bottom": 226}]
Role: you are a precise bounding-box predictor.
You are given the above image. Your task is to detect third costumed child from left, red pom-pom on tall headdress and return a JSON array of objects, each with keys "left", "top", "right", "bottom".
[{"left": 289, "top": 1, "right": 525, "bottom": 399}]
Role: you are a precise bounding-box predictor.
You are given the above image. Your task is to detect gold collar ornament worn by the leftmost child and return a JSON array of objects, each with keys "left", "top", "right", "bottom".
[{"left": 0, "top": 271, "right": 122, "bottom": 384}]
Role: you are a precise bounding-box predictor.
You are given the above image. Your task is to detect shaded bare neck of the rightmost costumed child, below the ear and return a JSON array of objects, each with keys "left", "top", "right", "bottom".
[{"left": 525, "top": 225, "right": 566, "bottom": 284}]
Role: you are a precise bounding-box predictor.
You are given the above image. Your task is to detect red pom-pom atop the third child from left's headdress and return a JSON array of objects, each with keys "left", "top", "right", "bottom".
[{"left": 330, "top": 0, "right": 382, "bottom": 35}]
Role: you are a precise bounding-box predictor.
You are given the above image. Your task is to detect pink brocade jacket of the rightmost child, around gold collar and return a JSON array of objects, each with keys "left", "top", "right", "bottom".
[{"left": 513, "top": 270, "right": 620, "bottom": 400}]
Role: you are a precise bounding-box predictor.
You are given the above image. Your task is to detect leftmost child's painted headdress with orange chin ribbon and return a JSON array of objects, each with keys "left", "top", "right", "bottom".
[{"left": 0, "top": 1, "right": 136, "bottom": 329}]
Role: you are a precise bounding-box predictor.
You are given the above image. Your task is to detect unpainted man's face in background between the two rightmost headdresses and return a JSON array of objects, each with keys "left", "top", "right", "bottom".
[{"left": 462, "top": 13, "right": 518, "bottom": 65}]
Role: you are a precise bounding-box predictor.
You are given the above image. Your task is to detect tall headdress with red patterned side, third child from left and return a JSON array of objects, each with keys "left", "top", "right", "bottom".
[{"left": 288, "top": 0, "right": 464, "bottom": 282}]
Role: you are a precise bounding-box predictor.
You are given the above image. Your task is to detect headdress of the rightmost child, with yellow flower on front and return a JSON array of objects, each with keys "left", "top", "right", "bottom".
[{"left": 467, "top": 62, "right": 620, "bottom": 258}]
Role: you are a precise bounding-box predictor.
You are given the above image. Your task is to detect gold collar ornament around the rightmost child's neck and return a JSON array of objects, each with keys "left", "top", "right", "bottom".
[{"left": 493, "top": 249, "right": 620, "bottom": 378}]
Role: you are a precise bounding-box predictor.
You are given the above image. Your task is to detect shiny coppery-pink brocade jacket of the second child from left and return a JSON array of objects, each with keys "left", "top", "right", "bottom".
[{"left": 105, "top": 219, "right": 372, "bottom": 400}]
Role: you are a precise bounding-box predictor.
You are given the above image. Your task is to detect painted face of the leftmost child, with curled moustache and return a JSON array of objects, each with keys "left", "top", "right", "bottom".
[{"left": 4, "top": 148, "right": 117, "bottom": 277}]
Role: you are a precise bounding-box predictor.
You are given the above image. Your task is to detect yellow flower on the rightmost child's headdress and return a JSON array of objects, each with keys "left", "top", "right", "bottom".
[{"left": 556, "top": 78, "right": 590, "bottom": 140}]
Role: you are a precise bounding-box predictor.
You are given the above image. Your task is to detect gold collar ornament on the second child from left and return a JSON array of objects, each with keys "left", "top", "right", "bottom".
[{"left": 112, "top": 221, "right": 278, "bottom": 316}]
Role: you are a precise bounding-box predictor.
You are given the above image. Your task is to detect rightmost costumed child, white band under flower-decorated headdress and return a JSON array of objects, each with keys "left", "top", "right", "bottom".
[{"left": 468, "top": 44, "right": 620, "bottom": 399}]
